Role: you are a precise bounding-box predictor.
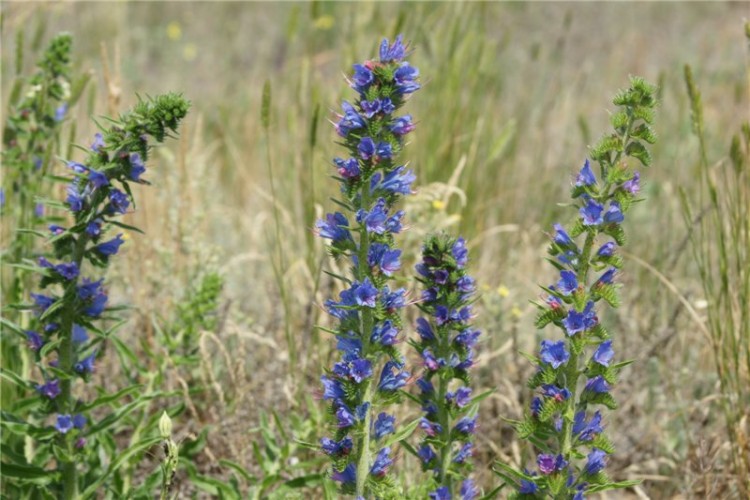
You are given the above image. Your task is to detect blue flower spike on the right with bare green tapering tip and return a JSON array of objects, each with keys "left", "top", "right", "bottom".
[{"left": 497, "top": 77, "right": 656, "bottom": 500}]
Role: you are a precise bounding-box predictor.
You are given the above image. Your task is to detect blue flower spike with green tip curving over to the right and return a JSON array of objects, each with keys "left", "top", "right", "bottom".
[{"left": 11, "top": 94, "right": 189, "bottom": 499}]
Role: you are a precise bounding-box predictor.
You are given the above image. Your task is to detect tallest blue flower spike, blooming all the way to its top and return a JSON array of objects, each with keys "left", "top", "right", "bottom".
[{"left": 316, "top": 36, "right": 419, "bottom": 498}]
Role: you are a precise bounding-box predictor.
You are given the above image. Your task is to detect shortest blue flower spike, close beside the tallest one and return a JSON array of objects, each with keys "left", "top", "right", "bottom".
[{"left": 414, "top": 236, "right": 479, "bottom": 500}]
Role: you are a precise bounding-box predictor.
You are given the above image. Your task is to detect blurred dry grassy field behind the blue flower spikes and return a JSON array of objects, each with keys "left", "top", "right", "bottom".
[{"left": 2, "top": 2, "right": 750, "bottom": 498}]
